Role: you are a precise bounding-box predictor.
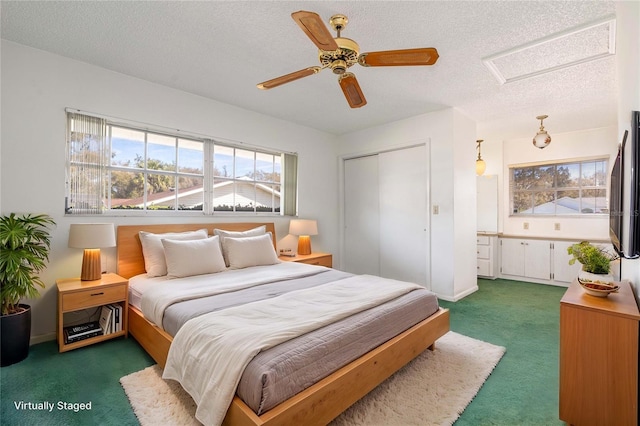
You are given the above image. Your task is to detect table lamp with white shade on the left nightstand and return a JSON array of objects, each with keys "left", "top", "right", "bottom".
[{"left": 69, "top": 223, "right": 116, "bottom": 281}]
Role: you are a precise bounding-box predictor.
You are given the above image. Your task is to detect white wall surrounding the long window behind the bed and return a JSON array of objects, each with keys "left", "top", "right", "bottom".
[{"left": 0, "top": 40, "right": 338, "bottom": 342}]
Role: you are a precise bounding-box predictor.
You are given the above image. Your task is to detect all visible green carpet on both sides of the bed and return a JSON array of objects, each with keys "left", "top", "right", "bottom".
[{"left": 0, "top": 280, "right": 565, "bottom": 426}]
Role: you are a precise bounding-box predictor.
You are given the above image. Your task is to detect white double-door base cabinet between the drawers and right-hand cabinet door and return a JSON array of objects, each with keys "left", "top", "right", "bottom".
[{"left": 500, "top": 238, "right": 552, "bottom": 280}]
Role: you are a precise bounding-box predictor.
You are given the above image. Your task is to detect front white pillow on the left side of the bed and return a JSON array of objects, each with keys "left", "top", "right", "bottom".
[{"left": 162, "top": 236, "right": 227, "bottom": 278}]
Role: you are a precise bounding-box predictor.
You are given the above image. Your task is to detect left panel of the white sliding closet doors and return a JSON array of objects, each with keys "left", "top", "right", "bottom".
[{"left": 343, "top": 155, "right": 380, "bottom": 275}]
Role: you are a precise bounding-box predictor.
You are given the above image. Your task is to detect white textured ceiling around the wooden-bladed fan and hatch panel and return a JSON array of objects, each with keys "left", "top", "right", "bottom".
[{"left": 0, "top": 1, "right": 617, "bottom": 137}]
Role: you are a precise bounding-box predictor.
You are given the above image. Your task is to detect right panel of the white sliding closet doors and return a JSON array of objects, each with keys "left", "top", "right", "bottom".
[{"left": 378, "top": 145, "right": 427, "bottom": 285}]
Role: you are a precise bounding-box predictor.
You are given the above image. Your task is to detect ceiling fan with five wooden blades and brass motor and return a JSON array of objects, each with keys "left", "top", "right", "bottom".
[{"left": 257, "top": 10, "right": 438, "bottom": 108}]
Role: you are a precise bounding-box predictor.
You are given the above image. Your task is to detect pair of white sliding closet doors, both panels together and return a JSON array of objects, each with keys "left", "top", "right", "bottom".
[{"left": 343, "top": 145, "right": 428, "bottom": 286}]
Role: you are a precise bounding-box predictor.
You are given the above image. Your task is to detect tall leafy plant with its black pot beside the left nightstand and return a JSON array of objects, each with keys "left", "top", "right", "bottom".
[{"left": 0, "top": 213, "right": 55, "bottom": 367}]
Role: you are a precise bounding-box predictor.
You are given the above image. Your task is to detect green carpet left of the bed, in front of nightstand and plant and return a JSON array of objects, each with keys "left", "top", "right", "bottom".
[{"left": 0, "top": 337, "right": 155, "bottom": 426}]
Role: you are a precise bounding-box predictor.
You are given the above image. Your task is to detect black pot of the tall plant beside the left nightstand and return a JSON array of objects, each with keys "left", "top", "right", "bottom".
[{"left": 0, "top": 305, "right": 31, "bottom": 367}]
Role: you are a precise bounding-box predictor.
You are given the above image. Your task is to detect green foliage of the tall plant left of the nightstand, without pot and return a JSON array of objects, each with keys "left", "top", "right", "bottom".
[{"left": 0, "top": 213, "right": 55, "bottom": 315}]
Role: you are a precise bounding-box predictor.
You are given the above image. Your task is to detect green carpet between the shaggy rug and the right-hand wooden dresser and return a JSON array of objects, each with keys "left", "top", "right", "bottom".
[{"left": 441, "top": 280, "right": 566, "bottom": 426}]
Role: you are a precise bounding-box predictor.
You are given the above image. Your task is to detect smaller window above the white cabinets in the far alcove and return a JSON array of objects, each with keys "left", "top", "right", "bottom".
[{"left": 509, "top": 158, "right": 609, "bottom": 215}]
